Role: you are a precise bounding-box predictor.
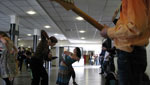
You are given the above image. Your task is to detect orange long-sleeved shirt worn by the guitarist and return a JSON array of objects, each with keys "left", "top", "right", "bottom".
[{"left": 107, "top": 0, "right": 150, "bottom": 52}]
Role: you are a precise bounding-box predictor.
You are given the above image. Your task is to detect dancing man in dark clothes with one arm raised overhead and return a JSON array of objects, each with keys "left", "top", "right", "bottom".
[{"left": 31, "top": 30, "right": 58, "bottom": 85}]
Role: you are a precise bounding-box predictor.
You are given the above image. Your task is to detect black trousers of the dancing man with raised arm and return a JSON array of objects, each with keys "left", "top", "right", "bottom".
[{"left": 31, "top": 59, "right": 48, "bottom": 85}]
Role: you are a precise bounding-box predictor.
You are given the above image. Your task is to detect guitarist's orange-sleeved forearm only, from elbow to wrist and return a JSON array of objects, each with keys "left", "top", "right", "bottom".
[{"left": 107, "top": 23, "right": 143, "bottom": 39}]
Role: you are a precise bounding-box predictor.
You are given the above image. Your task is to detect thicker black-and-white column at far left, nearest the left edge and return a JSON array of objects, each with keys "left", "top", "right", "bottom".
[{"left": 9, "top": 15, "right": 19, "bottom": 46}]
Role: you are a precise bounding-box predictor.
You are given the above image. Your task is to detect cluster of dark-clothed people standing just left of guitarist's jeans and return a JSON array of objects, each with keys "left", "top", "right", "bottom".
[{"left": 99, "top": 43, "right": 116, "bottom": 74}]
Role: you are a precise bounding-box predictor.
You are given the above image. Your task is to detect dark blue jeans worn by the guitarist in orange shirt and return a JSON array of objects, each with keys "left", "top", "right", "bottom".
[{"left": 117, "top": 46, "right": 147, "bottom": 85}]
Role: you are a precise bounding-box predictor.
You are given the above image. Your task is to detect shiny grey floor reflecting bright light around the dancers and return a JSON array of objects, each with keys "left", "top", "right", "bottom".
[{"left": 0, "top": 66, "right": 104, "bottom": 85}]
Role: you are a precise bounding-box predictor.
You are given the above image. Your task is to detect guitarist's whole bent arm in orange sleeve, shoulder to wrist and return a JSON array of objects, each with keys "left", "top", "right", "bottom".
[{"left": 107, "top": 0, "right": 148, "bottom": 39}]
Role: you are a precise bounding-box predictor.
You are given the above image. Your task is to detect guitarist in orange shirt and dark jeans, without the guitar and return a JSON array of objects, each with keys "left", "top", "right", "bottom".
[{"left": 101, "top": 0, "right": 150, "bottom": 85}]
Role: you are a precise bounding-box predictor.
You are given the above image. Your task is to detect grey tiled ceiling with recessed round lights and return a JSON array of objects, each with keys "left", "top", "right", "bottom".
[{"left": 0, "top": 0, "right": 121, "bottom": 43}]
